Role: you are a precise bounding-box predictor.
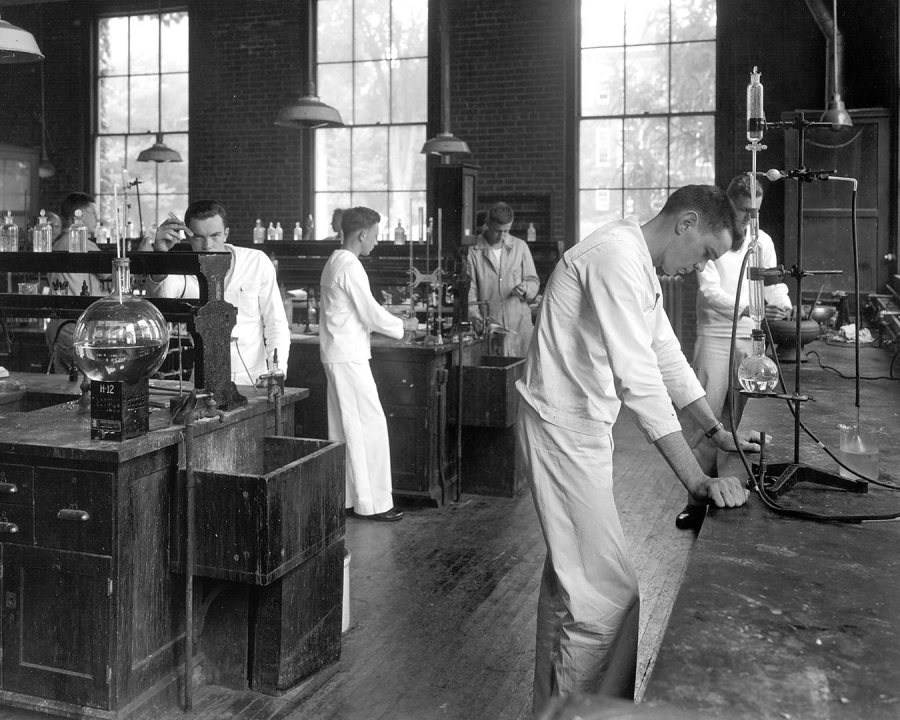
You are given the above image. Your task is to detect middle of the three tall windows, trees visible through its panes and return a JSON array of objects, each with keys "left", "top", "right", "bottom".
[{"left": 315, "top": 0, "right": 428, "bottom": 239}]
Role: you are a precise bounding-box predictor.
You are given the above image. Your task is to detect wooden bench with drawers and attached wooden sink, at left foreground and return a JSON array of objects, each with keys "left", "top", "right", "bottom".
[{"left": 0, "top": 373, "right": 344, "bottom": 719}]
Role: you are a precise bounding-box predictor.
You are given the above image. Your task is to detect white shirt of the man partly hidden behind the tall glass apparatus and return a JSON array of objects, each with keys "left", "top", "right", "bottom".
[{"left": 697, "top": 227, "right": 792, "bottom": 338}]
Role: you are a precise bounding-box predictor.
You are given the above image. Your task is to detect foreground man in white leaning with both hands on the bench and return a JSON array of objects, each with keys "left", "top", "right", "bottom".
[{"left": 517, "top": 185, "right": 759, "bottom": 716}]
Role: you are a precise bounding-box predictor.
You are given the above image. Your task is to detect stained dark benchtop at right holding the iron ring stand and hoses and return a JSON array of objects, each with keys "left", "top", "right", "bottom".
[{"left": 644, "top": 341, "right": 900, "bottom": 720}]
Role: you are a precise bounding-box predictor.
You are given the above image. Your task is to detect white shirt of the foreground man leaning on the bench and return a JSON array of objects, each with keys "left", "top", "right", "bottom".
[{"left": 516, "top": 218, "right": 704, "bottom": 441}]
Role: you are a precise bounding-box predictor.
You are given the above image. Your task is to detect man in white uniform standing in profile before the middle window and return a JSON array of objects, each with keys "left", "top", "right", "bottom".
[{"left": 319, "top": 207, "right": 416, "bottom": 522}]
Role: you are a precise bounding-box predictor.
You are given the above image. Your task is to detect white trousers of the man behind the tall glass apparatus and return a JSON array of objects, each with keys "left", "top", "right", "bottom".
[{"left": 679, "top": 335, "right": 752, "bottom": 477}]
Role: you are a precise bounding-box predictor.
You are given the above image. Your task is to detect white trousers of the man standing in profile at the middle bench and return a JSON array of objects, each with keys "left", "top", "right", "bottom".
[{"left": 324, "top": 360, "right": 394, "bottom": 515}]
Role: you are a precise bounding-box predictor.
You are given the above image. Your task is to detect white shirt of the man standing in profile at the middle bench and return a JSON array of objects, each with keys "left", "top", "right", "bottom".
[{"left": 319, "top": 248, "right": 403, "bottom": 363}]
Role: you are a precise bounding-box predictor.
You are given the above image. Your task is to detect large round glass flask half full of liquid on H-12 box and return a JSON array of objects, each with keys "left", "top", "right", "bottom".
[{"left": 74, "top": 258, "right": 169, "bottom": 383}]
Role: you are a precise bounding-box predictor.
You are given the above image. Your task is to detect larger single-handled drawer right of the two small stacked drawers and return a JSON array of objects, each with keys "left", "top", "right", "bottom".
[{"left": 34, "top": 467, "right": 113, "bottom": 555}]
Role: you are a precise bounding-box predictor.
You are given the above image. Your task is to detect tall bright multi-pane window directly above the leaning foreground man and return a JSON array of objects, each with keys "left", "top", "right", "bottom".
[{"left": 579, "top": 0, "right": 716, "bottom": 242}]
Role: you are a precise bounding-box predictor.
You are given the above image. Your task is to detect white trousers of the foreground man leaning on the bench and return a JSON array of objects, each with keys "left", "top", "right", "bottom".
[{"left": 517, "top": 401, "right": 639, "bottom": 717}]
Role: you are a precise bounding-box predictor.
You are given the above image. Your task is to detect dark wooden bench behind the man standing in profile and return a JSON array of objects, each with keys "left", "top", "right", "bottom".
[{"left": 287, "top": 333, "right": 482, "bottom": 506}]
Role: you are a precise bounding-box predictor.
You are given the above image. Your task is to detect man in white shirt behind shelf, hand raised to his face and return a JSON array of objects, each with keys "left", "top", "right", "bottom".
[{"left": 141, "top": 200, "right": 291, "bottom": 385}]
